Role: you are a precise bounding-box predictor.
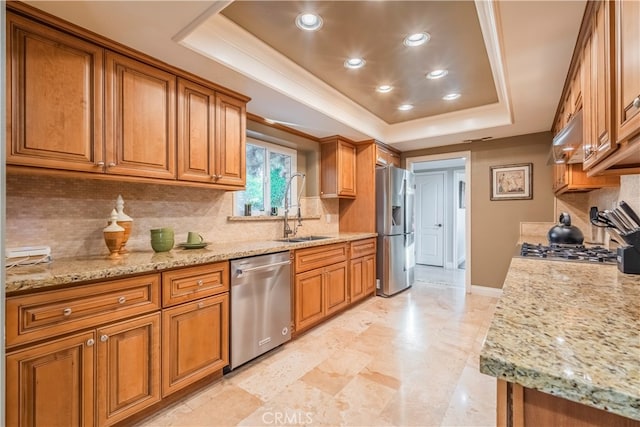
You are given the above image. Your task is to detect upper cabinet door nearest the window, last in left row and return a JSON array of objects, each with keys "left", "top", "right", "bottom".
[{"left": 215, "top": 93, "right": 247, "bottom": 188}]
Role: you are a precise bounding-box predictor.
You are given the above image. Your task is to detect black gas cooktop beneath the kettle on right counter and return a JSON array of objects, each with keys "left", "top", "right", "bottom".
[{"left": 520, "top": 243, "right": 617, "bottom": 264}]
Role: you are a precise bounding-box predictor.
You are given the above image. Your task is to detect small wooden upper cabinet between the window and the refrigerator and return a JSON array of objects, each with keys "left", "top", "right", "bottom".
[{"left": 320, "top": 136, "right": 356, "bottom": 199}]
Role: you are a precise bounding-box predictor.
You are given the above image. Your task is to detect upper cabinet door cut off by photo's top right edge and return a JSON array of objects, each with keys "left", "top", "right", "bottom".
[{"left": 616, "top": 1, "right": 640, "bottom": 141}]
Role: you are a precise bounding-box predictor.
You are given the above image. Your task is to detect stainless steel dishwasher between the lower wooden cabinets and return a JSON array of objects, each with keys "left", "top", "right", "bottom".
[{"left": 229, "top": 252, "right": 291, "bottom": 369}]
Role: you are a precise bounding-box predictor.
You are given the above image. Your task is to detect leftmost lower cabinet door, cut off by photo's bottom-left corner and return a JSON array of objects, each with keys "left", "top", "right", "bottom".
[{"left": 6, "top": 332, "right": 95, "bottom": 426}]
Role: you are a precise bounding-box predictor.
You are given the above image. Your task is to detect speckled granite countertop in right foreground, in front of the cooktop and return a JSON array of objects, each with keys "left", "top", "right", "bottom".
[{"left": 480, "top": 257, "right": 640, "bottom": 420}]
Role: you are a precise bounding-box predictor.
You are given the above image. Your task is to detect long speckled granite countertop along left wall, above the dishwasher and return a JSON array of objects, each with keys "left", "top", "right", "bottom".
[{"left": 5, "top": 233, "right": 376, "bottom": 296}]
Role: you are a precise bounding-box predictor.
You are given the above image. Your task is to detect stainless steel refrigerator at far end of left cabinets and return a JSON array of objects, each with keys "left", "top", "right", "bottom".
[{"left": 376, "top": 165, "right": 415, "bottom": 296}]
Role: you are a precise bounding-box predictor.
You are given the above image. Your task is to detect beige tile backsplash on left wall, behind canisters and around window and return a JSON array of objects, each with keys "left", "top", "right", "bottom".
[{"left": 5, "top": 174, "right": 338, "bottom": 258}]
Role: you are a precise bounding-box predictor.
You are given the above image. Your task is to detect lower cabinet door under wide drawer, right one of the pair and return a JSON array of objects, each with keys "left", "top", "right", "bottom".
[{"left": 96, "top": 313, "right": 160, "bottom": 426}]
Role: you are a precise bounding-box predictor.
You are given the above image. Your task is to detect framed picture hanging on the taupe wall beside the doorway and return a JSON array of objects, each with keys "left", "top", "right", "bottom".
[{"left": 490, "top": 163, "right": 533, "bottom": 200}]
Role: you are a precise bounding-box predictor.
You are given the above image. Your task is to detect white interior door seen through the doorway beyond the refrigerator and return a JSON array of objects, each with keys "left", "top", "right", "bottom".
[{"left": 416, "top": 172, "right": 445, "bottom": 267}]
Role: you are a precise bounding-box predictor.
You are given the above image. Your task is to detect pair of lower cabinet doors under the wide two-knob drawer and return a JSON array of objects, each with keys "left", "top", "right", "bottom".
[{"left": 6, "top": 313, "right": 160, "bottom": 426}]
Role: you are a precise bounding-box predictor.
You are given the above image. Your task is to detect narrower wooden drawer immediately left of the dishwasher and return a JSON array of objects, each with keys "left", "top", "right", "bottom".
[{"left": 162, "top": 261, "right": 229, "bottom": 307}]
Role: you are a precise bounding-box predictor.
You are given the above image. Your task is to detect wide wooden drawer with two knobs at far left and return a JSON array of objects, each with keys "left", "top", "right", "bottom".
[{"left": 6, "top": 274, "right": 160, "bottom": 347}]
